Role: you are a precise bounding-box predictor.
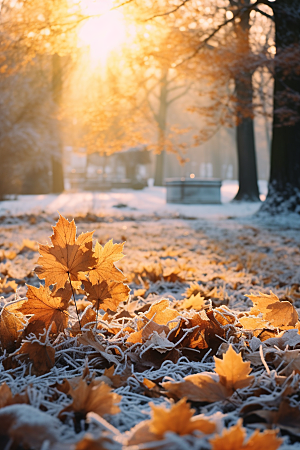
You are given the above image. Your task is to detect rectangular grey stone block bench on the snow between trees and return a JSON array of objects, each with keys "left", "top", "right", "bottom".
[{"left": 165, "top": 178, "right": 222, "bottom": 204}]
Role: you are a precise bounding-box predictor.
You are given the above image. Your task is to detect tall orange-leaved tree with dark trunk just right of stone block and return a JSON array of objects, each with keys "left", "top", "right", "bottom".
[{"left": 136, "top": 0, "right": 259, "bottom": 201}]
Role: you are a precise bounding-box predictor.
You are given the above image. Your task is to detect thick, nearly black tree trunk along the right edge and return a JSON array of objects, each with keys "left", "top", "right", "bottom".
[{"left": 261, "top": 0, "right": 300, "bottom": 214}]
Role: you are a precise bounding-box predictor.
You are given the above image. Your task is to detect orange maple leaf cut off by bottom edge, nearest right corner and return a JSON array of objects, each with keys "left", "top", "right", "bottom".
[{"left": 209, "top": 420, "right": 283, "bottom": 450}]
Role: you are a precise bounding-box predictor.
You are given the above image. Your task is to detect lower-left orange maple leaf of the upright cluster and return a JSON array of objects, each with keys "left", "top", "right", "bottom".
[{"left": 18, "top": 285, "right": 71, "bottom": 336}]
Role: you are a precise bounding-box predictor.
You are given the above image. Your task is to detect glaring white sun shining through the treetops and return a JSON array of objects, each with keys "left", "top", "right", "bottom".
[{"left": 78, "top": 0, "right": 126, "bottom": 65}]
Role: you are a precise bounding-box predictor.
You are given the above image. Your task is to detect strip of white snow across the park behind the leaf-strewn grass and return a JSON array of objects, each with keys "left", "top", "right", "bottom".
[{"left": 0, "top": 181, "right": 267, "bottom": 218}]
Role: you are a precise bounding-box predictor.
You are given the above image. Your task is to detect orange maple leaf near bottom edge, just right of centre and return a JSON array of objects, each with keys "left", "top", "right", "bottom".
[{"left": 128, "top": 399, "right": 216, "bottom": 445}]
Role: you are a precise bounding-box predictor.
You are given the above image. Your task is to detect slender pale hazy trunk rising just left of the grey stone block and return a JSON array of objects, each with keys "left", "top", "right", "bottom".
[{"left": 154, "top": 69, "right": 168, "bottom": 186}]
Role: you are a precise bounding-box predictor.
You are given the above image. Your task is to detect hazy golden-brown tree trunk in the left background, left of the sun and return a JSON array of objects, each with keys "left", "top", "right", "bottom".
[{"left": 52, "top": 54, "right": 64, "bottom": 194}]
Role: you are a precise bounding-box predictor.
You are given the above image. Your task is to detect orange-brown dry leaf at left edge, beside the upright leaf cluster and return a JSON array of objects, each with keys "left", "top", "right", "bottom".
[{"left": 0, "top": 300, "right": 26, "bottom": 353}]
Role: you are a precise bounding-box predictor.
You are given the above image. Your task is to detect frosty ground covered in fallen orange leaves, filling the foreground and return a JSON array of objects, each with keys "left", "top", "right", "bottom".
[{"left": 0, "top": 216, "right": 300, "bottom": 450}]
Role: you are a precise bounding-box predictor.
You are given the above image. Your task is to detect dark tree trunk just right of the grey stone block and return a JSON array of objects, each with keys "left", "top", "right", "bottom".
[{"left": 234, "top": 0, "right": 260, "bottom": 202}]
